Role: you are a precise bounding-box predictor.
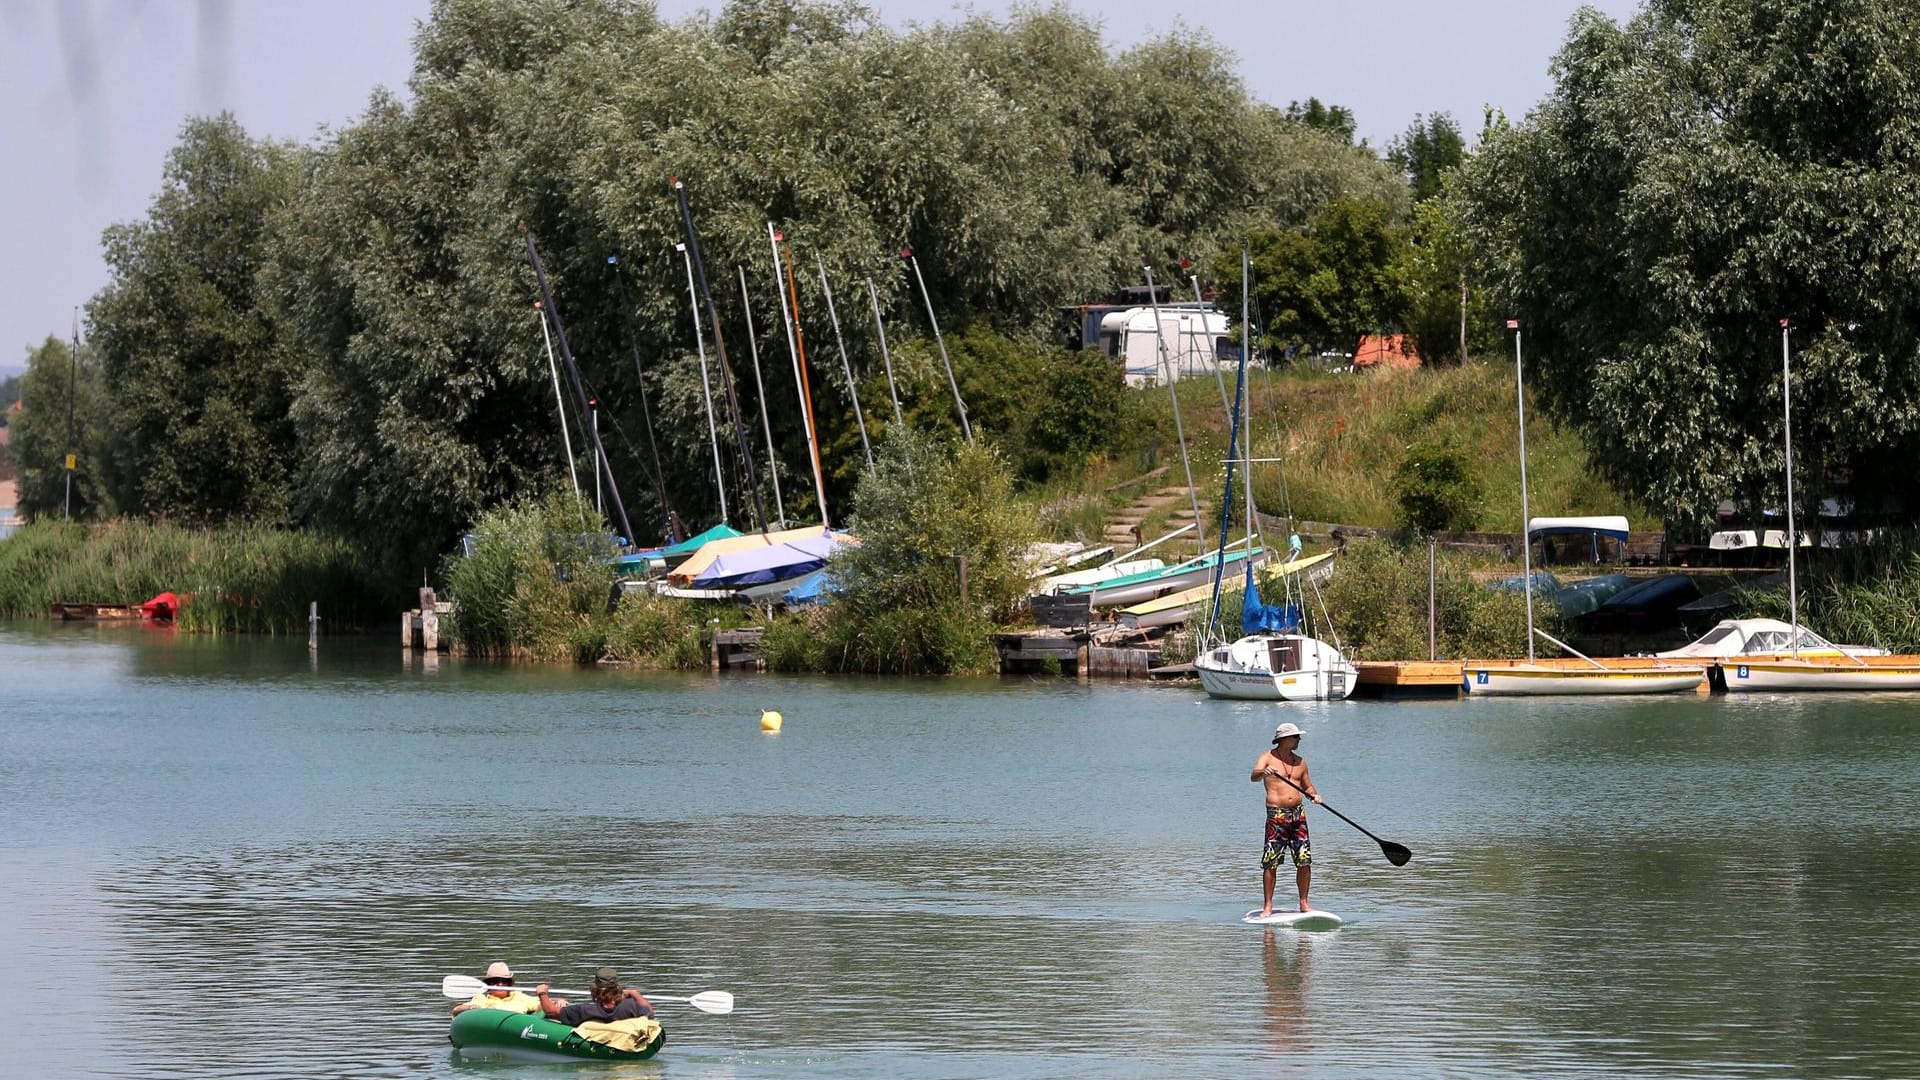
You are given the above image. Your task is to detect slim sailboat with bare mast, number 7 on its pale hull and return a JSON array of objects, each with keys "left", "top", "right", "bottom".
[{"left": 1461, "top": 319, "right": 1707, "bottom": 696}]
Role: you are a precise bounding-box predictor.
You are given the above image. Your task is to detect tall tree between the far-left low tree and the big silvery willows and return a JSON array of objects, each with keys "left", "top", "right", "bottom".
[{"left": 88, "top": 115, "right": 300, "bottom": 523}]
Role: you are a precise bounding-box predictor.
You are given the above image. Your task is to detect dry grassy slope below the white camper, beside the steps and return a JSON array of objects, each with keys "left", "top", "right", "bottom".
[{"left": 1033, "top": 361, "right": 1659, "bottom": 538}]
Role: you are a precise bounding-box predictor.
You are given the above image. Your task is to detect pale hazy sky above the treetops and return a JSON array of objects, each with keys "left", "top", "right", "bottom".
[{"left": 0, "top": 0, "right": 1636, "bottom": 371}]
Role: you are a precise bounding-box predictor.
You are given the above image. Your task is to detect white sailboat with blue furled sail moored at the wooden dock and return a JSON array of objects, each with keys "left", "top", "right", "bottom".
[{"left": 1194, "top": 250, "right": 1359, "bottom": 701}]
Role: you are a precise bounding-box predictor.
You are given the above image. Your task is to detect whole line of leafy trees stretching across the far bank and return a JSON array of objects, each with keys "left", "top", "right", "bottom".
[{"left": 13, "top": 0, "right": 1920, "bottom": 567}]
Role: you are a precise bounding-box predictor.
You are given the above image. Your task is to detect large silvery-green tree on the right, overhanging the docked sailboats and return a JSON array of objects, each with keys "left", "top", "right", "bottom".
[{"left": 1463, "top": 0, "right": 1920, "bottom": 521}]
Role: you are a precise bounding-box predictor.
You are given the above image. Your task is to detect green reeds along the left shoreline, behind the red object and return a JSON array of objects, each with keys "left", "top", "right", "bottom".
[{"left": 0, "top": 521, "right": 397, "bottom": 634}]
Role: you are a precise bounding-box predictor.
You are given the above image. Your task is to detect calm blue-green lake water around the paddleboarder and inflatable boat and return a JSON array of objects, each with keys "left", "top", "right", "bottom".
[{"left": 11, "top": 623, "right": 1920, "bottom": 1080}]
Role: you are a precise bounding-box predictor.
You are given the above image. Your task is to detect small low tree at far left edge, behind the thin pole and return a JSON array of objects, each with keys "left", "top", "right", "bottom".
[{"left": 8, "top": 338, "right": 115, "bottom": 517}]
